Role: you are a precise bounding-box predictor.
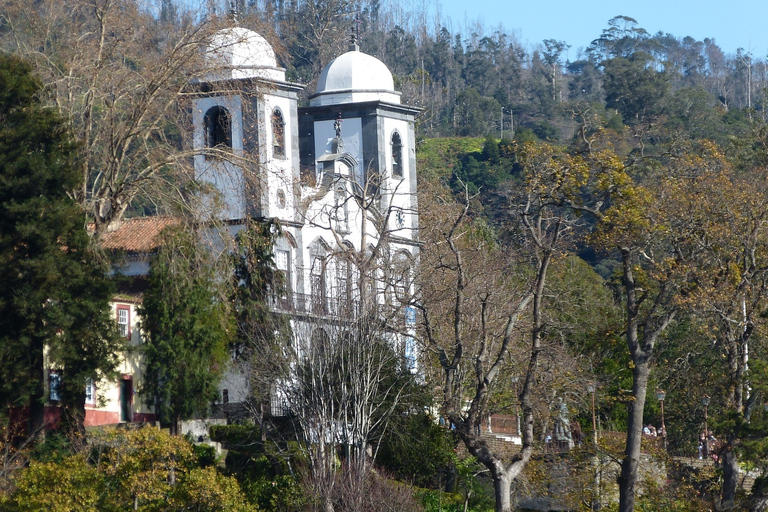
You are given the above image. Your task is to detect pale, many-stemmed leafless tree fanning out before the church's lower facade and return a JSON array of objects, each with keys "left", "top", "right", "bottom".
[{"left": 281, "top": 308, "right": 413, "bottom": 510}]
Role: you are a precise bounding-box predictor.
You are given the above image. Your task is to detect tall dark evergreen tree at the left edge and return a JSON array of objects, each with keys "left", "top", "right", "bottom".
[{"left": 0, "top": 55, "right": 119, "bottom": 432}]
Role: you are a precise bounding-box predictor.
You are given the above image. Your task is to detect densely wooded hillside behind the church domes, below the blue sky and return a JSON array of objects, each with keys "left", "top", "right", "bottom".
[{"left": 222, "top": 0, "right": 768, "bottom": 144}]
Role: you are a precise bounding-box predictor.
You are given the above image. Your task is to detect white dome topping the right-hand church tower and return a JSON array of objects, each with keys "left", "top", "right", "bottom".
[{"left": 310, "top": 50, "right": 400, "bottom": 106}]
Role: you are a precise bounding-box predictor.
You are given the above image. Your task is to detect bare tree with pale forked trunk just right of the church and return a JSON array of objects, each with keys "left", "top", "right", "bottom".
[{"left": 414, "top": 138, "right": 600, "bottom": 512}]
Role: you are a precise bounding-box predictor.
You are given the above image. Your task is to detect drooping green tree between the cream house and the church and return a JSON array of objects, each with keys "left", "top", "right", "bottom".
[{"left": 139, "top": 229, "right": 234, "bottom": 432}]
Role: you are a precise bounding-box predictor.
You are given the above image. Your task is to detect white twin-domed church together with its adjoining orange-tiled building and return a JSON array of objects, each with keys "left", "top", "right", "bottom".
[{"left": 57, "top": 22, "right": 419, "bottom": 425}]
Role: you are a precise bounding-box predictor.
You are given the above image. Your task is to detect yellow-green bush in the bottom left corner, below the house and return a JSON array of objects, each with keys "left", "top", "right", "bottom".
[{"left": 4, "top": 428, "right": 252, "bottom": 512}]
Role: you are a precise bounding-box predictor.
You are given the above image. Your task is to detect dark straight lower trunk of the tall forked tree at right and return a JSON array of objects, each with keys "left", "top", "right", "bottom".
[{"left": 619, "top": 360, "right": 650, "bottom": 512}]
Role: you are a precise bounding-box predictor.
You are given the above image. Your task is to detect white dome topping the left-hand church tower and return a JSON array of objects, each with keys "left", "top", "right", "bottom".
[{"left": 206, "top": 27, "right": 285, "bottom": 81}]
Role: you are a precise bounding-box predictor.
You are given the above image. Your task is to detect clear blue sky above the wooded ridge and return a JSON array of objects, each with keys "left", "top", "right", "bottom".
[{"left": 436, "top": 0, "right": 768, "bottom": 60}]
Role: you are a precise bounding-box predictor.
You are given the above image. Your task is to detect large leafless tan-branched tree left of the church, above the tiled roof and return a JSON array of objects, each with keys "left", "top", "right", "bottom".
[{"left": 0, "top": 0, "right": 252, "bottom": 231}]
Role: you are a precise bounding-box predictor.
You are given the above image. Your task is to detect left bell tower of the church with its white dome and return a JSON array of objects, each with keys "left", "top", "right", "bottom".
[{"left": 192, "top": 27, "right": 302, "bottom": 224}]
